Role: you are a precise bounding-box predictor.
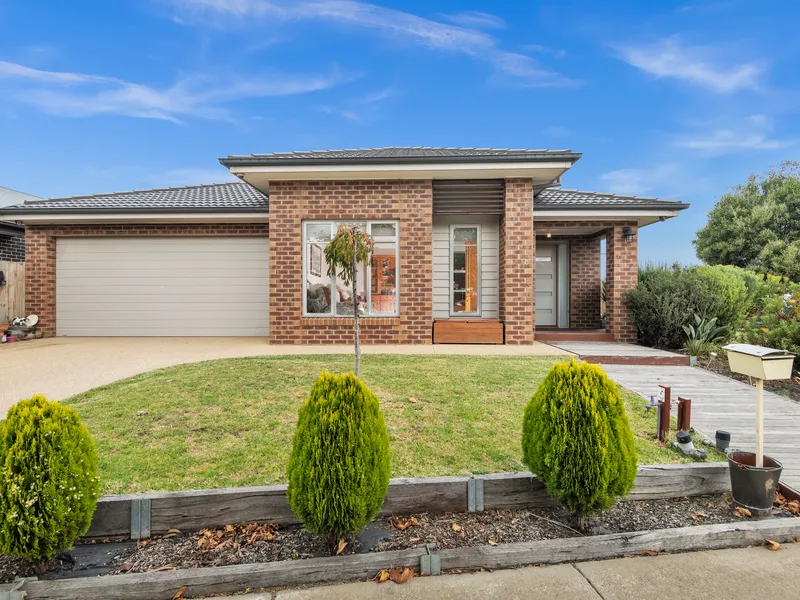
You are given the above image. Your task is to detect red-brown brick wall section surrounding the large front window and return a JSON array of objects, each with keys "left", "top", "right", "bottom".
[{"left": 269, "top": 180, "right": 433, "bottom": 344}]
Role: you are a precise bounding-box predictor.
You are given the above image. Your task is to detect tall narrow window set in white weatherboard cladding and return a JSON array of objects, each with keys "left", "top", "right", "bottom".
[{"left": 450, "top": 225, "right": 480, "bottom": 316}]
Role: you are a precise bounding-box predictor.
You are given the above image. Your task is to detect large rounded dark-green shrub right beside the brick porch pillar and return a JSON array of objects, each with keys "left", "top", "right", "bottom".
[{"left": 625, "top": 264, "right": 753, "bottom": 348}]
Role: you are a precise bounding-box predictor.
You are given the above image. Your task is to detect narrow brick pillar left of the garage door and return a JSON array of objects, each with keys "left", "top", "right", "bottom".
[{"left": 24, "top": 227, "right": 56, "bottom": 337}]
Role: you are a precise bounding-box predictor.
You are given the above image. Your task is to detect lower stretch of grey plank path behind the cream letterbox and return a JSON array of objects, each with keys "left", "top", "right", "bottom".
[{"left": 603, "top": 365, "right": 800, "bottom": 488}]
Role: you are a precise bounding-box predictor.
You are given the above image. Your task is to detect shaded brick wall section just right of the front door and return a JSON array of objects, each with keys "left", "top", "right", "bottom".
[{"left": 569, "top": 237, "right": 600, "bottom": 329}]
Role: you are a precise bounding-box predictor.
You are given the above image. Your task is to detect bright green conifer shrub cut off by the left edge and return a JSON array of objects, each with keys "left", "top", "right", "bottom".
[{"left": 0, "top": 395, "right": 100, "bottom": 566}]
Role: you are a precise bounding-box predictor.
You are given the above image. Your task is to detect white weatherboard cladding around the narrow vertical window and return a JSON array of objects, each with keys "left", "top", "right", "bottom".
[{"left": 433, "top": 215, "right": 500, "bottom": 319}]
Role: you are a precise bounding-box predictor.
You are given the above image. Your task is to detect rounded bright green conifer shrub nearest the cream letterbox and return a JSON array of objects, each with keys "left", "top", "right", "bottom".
[{"left": 522, "top": 360, "right": 636, "bottom": 527}]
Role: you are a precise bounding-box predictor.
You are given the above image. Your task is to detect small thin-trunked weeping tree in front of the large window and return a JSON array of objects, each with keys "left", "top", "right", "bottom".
[{"left": 325, "top": 224, "right": 374, "bottom": 377}]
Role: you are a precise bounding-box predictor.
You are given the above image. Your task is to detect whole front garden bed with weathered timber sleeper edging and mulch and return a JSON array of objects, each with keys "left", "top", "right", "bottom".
[{"left": 0, "top": 464, "right": 800, "bottom": 600}]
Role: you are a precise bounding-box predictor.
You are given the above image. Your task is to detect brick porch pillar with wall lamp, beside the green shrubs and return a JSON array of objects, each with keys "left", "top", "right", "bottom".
[{"left": 606, "top": 223, "right": 639, "bottom": 342}]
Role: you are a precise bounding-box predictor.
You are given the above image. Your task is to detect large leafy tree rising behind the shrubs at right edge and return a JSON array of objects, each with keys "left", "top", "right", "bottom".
[{"left": 694, "top": 162, "right": 800, "bottom": 278}]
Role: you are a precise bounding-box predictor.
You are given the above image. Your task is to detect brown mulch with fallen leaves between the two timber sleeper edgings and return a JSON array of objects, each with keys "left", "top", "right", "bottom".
[{"left": 0, "top": 494, "right": 800, "bottom": 583}]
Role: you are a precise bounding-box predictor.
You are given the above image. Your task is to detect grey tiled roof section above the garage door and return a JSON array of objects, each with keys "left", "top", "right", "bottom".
[{"left": 0, "top": 181, "right": 269, "bottom": 214}]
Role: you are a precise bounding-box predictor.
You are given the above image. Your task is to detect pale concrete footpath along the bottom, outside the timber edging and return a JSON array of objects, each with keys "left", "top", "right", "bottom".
[{"left": 216, "top": 544, "right": 800, "bottom": 600}]
